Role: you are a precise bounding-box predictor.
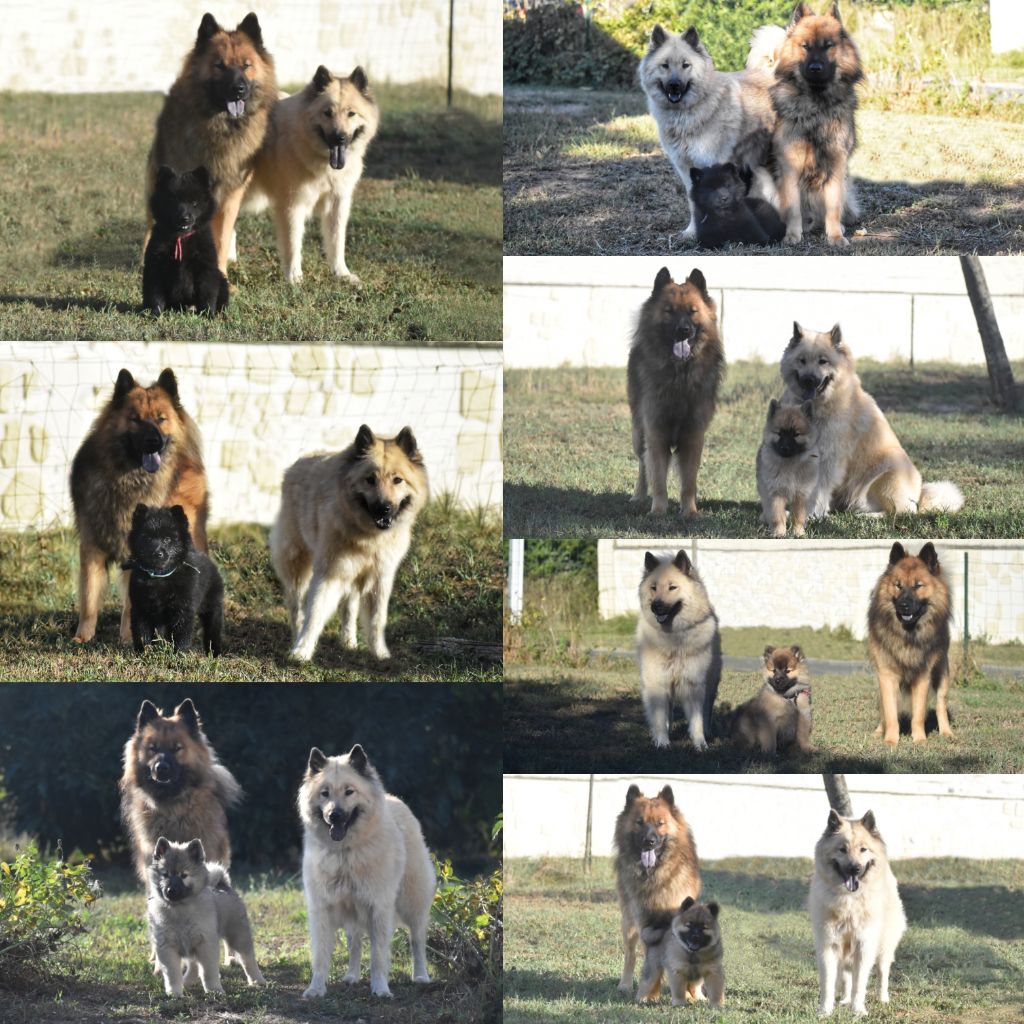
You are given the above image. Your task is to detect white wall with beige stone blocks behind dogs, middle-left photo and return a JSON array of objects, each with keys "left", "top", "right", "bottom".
[{"left": 0, "top": 342, "right": 502, "bottom": 529}]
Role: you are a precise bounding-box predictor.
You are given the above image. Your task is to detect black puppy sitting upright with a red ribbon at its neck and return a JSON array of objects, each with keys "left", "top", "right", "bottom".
[{"left": 142, "top": 167, "right": 227, "bottom": 316}]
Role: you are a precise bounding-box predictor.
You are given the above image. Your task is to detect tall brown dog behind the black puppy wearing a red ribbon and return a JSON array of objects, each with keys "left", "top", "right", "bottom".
[{"left": 145, "top": 13, "right": 278, "bottom": 273}]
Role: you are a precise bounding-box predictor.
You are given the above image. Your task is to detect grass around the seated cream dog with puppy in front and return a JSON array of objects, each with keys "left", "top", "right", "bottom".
[{"left": 505, "top": 362, "right": 1024, "bottom": 538}]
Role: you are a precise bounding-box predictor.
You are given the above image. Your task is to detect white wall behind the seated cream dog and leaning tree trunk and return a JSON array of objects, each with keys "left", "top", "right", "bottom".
[{"left": 505, "top": 254, "right": 1024, "bottom": 367}]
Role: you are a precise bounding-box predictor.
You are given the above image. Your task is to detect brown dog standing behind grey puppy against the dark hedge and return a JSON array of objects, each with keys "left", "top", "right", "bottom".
[{"left": 121, "top": 700, "right": 242, "bottom": 882}]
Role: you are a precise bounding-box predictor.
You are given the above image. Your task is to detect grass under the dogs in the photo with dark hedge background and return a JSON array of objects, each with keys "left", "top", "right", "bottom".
[{"left": 0, "top": 878, "right": 499, "bottom": 1024}]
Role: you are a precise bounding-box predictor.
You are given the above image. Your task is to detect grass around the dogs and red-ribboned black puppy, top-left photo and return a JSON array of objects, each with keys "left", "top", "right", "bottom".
[{"left": 0, "top": 86, "right": 502, "bottom": 343}]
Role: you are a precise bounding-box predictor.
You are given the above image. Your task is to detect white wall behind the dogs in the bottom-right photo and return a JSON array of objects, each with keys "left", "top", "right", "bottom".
[{"left": 503, "top": 774, "right": 1024, "bottom": 864}]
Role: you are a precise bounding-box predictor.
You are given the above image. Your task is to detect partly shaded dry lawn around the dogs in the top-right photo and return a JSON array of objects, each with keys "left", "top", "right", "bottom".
[{"left": 504, "top": 88, "right": 1024, "bottom": 256}]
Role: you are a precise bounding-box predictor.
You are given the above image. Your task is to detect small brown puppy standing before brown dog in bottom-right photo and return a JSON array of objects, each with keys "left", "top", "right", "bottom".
[{"left": 637, "top": 896, "right": 725, "bottom": 1007}]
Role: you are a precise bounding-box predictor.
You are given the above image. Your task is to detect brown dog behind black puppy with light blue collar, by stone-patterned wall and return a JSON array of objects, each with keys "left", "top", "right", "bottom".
[{"left": 71, "top": 370, "right": 209, "bottom": 638}]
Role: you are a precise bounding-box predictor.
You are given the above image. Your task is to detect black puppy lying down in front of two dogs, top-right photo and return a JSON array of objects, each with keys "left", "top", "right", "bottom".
[{"left": 690, "top": 164, "right": 785, "bottom": 249}]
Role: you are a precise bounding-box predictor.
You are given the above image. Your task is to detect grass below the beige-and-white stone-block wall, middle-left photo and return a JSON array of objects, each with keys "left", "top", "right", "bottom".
[{"left": 0, "top": 500, "right": 503, "bottom": 682}]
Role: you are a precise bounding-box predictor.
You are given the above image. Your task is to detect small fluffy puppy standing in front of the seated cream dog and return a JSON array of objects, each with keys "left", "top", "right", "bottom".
[{"left": 757, "top": 398, "right": 819, "bottom": 537}]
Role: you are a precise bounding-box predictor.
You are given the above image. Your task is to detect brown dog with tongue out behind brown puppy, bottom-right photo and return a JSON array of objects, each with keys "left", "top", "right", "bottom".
[{"left": 615, "top": 785, "right": 700, "bottom": 993}]
